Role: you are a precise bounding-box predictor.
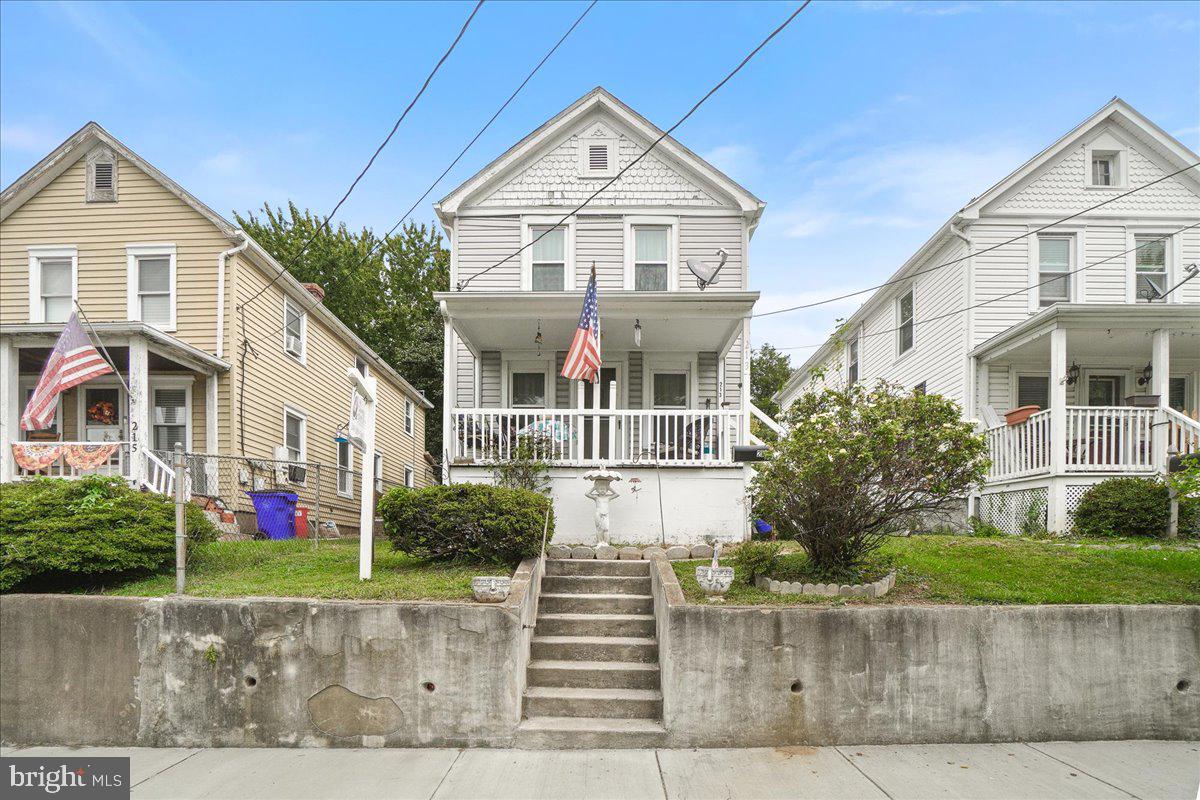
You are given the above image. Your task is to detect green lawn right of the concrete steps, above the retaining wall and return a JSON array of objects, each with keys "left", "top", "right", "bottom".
[{"left": 674, "top": 536, "right": 1200, "bottom": 606}]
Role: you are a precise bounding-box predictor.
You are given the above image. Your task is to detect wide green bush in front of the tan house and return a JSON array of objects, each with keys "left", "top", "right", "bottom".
[{"left": 0, "top": 476, "right": 217, "bottom": 591}]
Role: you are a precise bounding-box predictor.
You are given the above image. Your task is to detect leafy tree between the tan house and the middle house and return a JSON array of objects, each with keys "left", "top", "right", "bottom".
[{"left": 234, "top": 203, "right": 450, "bottom": 462}]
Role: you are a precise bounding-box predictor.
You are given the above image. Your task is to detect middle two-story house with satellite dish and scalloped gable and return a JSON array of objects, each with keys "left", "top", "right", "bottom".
[{"left": 436, "top": 89, "right": 763, "bottom": 543}]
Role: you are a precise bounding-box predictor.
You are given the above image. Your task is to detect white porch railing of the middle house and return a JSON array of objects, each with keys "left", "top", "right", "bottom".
[{"left": 449, "top": 408, "right": 743, "bottom": 467}]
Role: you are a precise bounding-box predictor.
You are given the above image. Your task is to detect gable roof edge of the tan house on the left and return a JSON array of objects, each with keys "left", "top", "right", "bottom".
[{"left": 0, "top": 122, "right": 433, "bottom": 408}]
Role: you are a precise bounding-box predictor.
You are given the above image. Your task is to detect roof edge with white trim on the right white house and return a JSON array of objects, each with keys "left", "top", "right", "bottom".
[{"left": 778, "top": 97, "right": 1200, "bottom": 396}]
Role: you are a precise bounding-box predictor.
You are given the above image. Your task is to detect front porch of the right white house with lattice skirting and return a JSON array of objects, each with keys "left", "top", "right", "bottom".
[{"left": 972, "top": 303, "right": 1200, "bottom": 531}]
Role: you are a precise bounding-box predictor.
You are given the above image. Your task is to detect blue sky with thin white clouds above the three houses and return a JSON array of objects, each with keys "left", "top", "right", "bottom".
[{"left": 0, "top": 0, "right": 1200, "bottom": 360}]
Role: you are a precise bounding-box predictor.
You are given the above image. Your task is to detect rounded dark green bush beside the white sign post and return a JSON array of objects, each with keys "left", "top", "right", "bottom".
[{"left": 379, "top": 483, "right": 554, "bottom": 565}]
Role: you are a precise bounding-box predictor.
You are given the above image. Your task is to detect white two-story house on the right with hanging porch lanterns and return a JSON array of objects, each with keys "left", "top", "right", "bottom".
[{"left": 780, "top": 100, "right": 1200, "bottom": 533}]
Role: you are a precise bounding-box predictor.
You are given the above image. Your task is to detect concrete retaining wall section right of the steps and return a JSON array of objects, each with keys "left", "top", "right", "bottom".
[{"left": 653, "top": 560, "right": 1200, "bottom": 747}]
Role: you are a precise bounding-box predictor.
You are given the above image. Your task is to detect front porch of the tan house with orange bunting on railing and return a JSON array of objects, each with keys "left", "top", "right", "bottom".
[{"left": 0, "top": 323, "right": 228, "bottom": 494}]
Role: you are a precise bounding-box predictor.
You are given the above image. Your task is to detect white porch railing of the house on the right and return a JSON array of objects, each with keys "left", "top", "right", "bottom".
[{"left": 984, "top": 407, "right": 1200, "bottom": 481}]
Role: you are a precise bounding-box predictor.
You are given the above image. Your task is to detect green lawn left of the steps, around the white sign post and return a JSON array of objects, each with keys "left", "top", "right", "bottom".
[{"left": 93, "top": 539, "right": 484, "bottom": 601}]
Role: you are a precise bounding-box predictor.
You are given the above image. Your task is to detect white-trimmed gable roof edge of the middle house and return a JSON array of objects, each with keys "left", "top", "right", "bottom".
[{"left": 433, "top": 86, "right": 766, "bottom": 224}]
